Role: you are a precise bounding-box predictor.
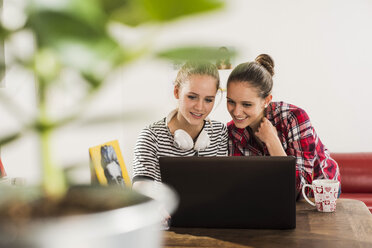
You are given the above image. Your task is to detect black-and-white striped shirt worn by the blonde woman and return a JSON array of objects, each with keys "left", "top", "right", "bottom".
[{"left": 132, "top": 118, "right": 228, "bottom": 182}]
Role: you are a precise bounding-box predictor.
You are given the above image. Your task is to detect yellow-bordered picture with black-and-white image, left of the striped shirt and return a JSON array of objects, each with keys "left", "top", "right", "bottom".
[{"left": 89, "top": 140, "right": 131, "bottom": 188}]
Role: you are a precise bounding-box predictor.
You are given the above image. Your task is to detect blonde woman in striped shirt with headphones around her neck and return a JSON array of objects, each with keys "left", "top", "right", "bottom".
[{"left": 133, "top": 62, "right": 228, "bottom": 186}]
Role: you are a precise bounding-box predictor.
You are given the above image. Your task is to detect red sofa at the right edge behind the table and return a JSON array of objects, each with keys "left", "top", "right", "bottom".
[{"left": 331, "top": 152, "right": 372, "bottom": 213}]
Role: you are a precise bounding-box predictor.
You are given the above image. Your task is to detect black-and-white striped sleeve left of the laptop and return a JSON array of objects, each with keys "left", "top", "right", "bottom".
[{"left": 133, "top": 128, "right": 160, "bottom": 182}]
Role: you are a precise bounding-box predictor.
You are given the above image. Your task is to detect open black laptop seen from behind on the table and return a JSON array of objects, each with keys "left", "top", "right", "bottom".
[{"left": 159, "top": 156, "right": 296, "bottom": 229}]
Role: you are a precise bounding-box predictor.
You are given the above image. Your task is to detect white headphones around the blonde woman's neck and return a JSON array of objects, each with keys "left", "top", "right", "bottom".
[{"left": 166, "top": 110, "right": 211, "bottom": 151}]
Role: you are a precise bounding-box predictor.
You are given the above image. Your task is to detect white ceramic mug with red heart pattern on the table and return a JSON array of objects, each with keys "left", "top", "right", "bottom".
[{"left": 302, "top": 179, "right": 340, "bottom": 212}]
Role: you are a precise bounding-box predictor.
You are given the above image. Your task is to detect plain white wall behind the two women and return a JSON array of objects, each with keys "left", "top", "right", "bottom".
[{"left": 0, "top": 0, "right": 372, "bottom": 185}]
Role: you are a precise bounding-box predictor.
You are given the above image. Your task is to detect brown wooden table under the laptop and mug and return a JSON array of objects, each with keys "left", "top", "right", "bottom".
[{"left": 164, "top": 199, "right": 372, "bottom": 248}]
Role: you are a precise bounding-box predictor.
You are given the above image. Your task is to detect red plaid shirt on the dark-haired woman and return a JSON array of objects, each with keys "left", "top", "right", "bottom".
[{"left": 227, "top": 102, "right": 341, "bottom": 197}]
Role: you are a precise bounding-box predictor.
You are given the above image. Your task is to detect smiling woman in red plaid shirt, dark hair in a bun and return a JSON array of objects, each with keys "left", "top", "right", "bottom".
[{"left": 227, "top": 54, "right": 341, "bottom": 198}]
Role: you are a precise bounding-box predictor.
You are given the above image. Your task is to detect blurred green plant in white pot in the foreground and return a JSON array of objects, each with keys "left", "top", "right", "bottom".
[{"left": 0, "top": 0, "right": 231, "bottom": 248}]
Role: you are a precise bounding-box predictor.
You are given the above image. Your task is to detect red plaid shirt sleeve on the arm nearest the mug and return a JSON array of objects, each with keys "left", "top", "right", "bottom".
[{"left": 286, "top": 109, "right": 340, "bottom": 197}]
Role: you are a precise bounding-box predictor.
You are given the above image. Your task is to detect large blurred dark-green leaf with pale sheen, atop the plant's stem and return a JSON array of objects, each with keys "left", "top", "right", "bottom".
[{"left": 26, "top": 10, "right": 126, "bottom": 78}]
